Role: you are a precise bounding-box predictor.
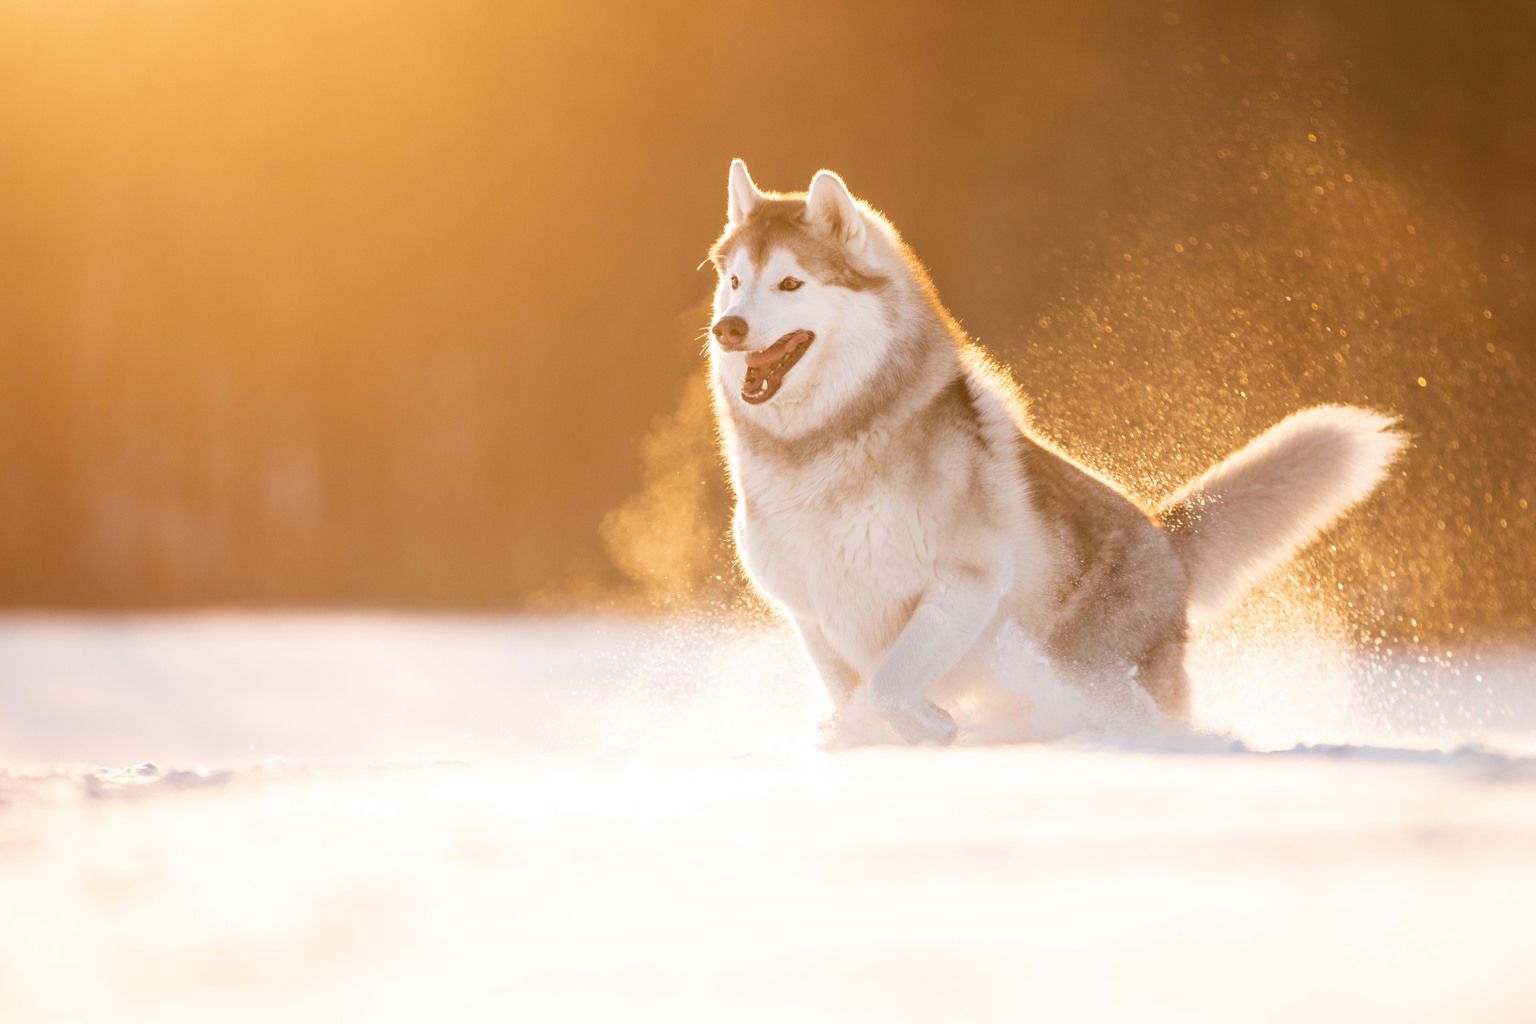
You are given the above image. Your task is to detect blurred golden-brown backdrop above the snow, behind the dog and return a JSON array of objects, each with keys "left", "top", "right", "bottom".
[{"left": 0, "top": 0, "right": 1536, "bottom": 640}]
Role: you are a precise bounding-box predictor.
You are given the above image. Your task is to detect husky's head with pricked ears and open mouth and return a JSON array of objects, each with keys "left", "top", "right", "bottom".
[{"left": 710, "top": 160, "right": 911, "bottom": 434}]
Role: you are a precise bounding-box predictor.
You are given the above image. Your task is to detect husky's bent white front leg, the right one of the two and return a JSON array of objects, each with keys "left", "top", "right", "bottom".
[{"left": 869, "top": 573, "right": 1003, "bottom": 743}]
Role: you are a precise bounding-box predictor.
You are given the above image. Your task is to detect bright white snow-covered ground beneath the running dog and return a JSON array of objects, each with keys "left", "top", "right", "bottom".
[{"left": 0, "top": 616, "right": 1536, "bottom": 1022}]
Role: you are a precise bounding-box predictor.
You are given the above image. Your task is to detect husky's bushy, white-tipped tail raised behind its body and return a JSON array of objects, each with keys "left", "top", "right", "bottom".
[{"left": 1157, "top": 405, "right": 1407, "bottom": 622}]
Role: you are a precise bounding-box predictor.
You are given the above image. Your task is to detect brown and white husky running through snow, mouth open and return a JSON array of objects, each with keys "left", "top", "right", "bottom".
[{"left": 710, "top": 160, "right": 1404, "bottom": 743}]
